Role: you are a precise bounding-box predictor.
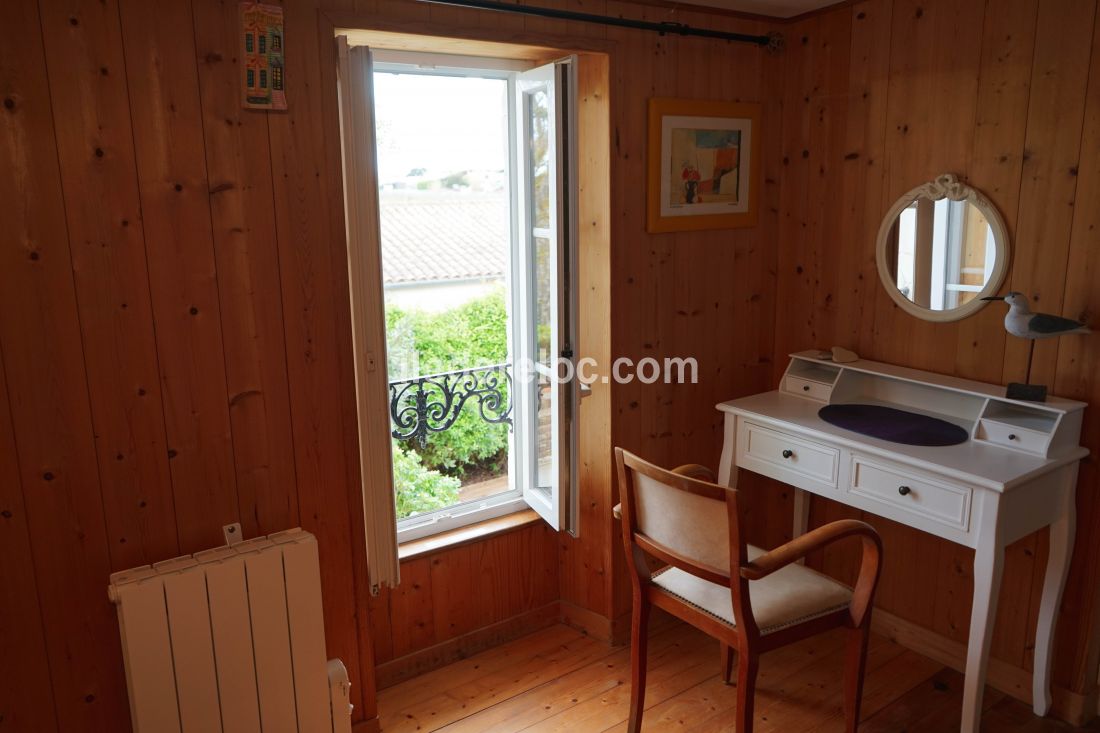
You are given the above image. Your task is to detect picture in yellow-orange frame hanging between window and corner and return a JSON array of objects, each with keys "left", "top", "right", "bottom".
[{"left": 646, "top": 98, "right": 760, "bottom": 232}]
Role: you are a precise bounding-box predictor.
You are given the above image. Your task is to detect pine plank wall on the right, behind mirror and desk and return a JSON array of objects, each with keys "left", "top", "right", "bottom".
[{"left": 765, "top": 0, "right": 1100, "bottom": 692}]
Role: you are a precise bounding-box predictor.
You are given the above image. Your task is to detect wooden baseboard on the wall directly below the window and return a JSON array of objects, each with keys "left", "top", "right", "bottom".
[{"left": 378, "top": 601, "right": 561, "bottom": 686}]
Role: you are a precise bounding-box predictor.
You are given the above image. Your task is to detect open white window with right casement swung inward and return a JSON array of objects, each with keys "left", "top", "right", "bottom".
[{"left": 341, "top": 39, "right": 576, "bottom": 540}]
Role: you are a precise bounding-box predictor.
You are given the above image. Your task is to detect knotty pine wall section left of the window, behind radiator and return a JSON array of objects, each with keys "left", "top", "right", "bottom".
[{"left": 0, "top": 0, "right": 373, "bottom": 732}]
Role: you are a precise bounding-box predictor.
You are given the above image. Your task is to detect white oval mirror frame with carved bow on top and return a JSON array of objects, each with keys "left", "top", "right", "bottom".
[{"left": 875, "top": 173, "right": 1009, "bottom": 322}]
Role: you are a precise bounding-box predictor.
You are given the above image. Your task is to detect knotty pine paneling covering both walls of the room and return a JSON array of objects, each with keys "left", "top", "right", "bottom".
[{"left": 8, "top": 0, "right": 1100, "bottom": 732}]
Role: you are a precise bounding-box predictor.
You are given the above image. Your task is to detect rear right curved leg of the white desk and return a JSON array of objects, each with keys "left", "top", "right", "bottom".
[{"left": 1032, "top": 463, "right": 1077, "bottom": 715}]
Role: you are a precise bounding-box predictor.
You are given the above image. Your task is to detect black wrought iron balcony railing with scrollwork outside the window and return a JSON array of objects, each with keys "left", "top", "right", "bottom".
[{"left": 389, "top": 363, "right": 512, "bottom": 447}]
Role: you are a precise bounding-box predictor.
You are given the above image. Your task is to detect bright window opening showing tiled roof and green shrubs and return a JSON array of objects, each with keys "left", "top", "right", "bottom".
[{"left": 374, "top": 70, "right": 514, "bottom": 519}]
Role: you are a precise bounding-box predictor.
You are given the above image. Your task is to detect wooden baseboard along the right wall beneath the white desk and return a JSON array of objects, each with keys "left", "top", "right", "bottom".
[{"left": 871, "top": 609, "right": 1097, "bottom": 725}]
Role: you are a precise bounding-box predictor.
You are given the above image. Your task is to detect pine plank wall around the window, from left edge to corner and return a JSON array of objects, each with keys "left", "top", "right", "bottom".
[{"left": 0, "top": 0, "right": 782, "bottom": 732}]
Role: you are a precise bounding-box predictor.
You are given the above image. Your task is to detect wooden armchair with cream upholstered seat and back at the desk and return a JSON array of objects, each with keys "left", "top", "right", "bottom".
[{"left": 615, "top": 448, "right": 882, "bottom": 733}]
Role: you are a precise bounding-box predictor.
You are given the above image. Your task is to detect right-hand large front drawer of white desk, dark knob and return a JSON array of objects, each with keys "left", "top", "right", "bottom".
[{"left": 848, "top": 456, "right": 972, "bottom": 532}]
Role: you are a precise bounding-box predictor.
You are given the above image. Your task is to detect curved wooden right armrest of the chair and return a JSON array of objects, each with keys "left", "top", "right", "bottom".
[{"left": 740, "top": 519, "right": 882, "bottom": 626}]
